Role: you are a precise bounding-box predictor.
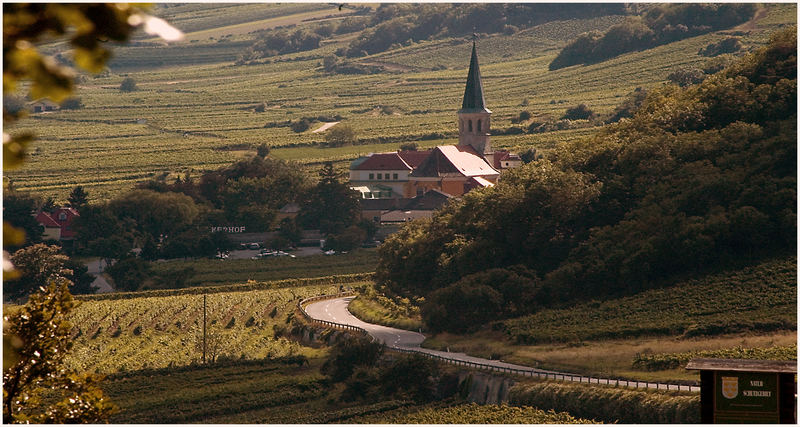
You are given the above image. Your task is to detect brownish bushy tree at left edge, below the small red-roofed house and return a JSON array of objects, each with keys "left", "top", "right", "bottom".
[{"left": 3, "top": 243, "right": 72, "bottom": 298}]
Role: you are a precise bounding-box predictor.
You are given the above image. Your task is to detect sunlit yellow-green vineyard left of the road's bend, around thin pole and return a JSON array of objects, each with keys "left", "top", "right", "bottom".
[{"left": 67, "top": 284, "right": 348, "bottom": 373}]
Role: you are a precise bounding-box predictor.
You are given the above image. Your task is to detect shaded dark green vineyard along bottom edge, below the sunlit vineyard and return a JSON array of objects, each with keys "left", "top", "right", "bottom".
[{"left": 103, "top": 359, "right": 588, "bottom": 424}]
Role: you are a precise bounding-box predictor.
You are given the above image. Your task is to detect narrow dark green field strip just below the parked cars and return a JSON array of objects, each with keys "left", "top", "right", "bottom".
[{"left": 151, "top": 249, "right": 378, "bottom": 286}]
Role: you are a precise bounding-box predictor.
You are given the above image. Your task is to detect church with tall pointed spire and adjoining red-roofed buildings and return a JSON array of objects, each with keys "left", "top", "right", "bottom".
[{"left": 350, "top": 41, "right": 522, "bottom": 206}]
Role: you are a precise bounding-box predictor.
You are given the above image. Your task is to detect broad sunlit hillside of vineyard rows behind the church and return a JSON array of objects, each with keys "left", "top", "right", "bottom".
[{"left": 7, "top": 4, "right": 796, "bottom": 200}]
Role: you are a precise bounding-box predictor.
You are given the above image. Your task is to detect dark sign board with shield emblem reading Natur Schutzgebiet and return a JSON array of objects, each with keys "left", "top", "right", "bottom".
[{"left": 714, "top": 372, "right": 779, "bottom": 423}]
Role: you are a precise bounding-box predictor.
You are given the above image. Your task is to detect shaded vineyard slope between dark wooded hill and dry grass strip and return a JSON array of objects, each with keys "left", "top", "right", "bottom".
[{"left": 498, "top": 258, "right": 797, "bottom": 344}]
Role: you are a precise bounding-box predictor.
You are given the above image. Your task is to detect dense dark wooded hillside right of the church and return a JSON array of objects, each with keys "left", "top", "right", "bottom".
[{"left": 377, "top": 28, "right": 797, "bottom": 332}]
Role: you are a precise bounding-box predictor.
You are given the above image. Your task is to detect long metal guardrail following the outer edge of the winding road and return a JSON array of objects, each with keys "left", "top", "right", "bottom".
[{"left": 297, "top": 293, "right": 700, "bottom": 393}]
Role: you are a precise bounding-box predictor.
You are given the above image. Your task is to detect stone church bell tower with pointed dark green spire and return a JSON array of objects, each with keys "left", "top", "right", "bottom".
[{"left": 458, "top": 40, "right": 493, "bottom": 156}]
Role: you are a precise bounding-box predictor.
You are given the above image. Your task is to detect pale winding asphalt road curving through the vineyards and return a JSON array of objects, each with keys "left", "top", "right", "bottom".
[{"left": 305, "top": 296, "right": 700, "bottom": 392}]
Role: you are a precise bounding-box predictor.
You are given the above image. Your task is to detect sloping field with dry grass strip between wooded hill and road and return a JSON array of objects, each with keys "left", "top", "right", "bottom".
[{"left": 423, "top": 258, "right": 797, "bottom": 381}]
